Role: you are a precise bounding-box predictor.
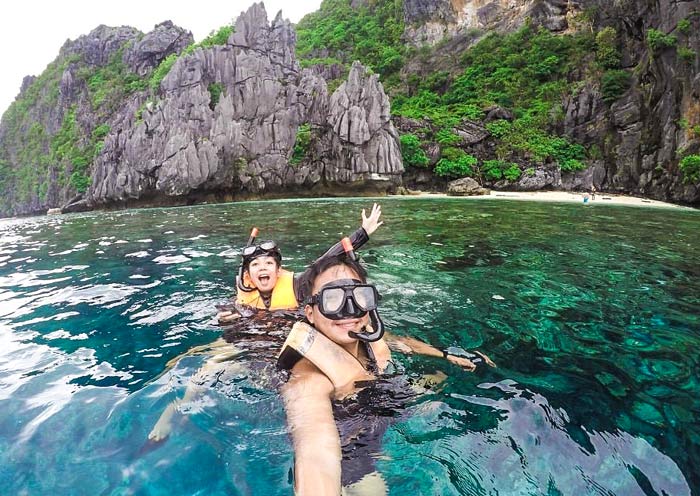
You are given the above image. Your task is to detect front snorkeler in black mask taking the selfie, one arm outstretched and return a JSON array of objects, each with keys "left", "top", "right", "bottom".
[{"left": 278, "top": 255, "right": 495, "bottom": 495}]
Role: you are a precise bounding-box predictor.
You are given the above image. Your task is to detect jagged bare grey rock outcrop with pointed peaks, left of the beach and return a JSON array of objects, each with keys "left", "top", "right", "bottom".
[{"left": 86, "top": 4, "right": 403, "bottom": 210}]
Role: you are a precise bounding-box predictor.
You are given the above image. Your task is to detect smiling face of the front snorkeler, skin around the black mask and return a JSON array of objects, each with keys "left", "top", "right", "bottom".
[{"left": 304, "top": 265, "right": 369, "bottom": 345}]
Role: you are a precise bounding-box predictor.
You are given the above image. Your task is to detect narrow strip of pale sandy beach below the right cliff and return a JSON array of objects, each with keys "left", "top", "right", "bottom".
[{"left": 410, "top": 190, "right": 690, "bottom": 209}]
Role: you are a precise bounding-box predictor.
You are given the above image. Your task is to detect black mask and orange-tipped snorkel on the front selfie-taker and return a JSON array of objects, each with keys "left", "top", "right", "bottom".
[{"left": 309, "top": 238, "right": 384, "bottom": 342}]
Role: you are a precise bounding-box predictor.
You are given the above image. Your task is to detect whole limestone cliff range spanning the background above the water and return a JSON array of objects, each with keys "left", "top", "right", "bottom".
[{"left": 0, "top": 0, "right": 700, "bottom": 215}]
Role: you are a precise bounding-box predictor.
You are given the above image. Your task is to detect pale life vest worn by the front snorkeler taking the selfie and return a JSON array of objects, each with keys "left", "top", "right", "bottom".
[{"left": 277, "top": 322, "right": 387, "bottom": 390}]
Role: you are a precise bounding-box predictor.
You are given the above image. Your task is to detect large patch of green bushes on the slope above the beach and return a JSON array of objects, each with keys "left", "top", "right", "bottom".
[{"left": 380, "top": 26, "right": 592, "bottom": 180}]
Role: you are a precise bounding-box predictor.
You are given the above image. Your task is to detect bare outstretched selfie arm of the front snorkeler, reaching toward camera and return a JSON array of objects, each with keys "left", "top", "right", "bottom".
[{"left": 282, "top": 360, "right": 342, "bottom": 496}]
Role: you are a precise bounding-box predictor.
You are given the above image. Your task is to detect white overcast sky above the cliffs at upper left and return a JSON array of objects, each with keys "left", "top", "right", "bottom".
[{"left": 0, "top": 0, "right": 321, "bottom": 114}]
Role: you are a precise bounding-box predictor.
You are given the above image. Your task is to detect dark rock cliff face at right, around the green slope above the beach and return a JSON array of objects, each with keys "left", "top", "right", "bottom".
[{"left": 397, "top": 0, "right": 700, "bottom": 205}]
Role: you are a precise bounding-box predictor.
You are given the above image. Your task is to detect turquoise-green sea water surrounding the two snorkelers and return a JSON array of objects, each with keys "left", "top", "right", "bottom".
[{"left": 0, "top": 198, "right": 700, "bottom": 496}]
